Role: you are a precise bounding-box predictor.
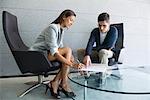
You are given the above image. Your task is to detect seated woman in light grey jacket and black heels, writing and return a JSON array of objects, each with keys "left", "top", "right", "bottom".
[{"left": 30, "top": 9, "right": 83, "bottom": 99}]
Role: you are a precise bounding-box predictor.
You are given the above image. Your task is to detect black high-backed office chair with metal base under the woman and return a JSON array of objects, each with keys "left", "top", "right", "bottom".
[{"left": 2, "top": 11, "right": 61, "bottom": 97}]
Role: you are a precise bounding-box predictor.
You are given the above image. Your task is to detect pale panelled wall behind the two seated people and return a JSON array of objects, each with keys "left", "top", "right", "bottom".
[{"left": 0, "top": 0, "right": 150, "bottom": 76}]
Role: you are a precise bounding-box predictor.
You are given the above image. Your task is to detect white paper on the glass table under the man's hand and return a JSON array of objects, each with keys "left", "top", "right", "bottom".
[{"left": 81, "top": 63, "right": 107, "bottom": 72}]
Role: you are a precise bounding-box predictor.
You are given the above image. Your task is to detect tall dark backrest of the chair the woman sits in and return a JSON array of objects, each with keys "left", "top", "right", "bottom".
[{"left": 3, "top": 11, "right": 28, "bottom": 51}]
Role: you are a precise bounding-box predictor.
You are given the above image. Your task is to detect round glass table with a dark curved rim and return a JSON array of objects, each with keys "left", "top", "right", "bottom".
[{"left": 69, "top": 66, "right": 150, "bottom": 100}]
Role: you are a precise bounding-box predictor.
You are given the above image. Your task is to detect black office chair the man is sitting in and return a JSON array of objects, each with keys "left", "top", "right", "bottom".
[{"left": 77, "top": 23, "right": 124, "bottom": 66}]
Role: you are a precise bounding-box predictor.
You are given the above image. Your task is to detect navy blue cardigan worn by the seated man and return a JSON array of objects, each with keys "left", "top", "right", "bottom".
[{"left": 85, "top": 26, "right": 118, "bottom": 55}]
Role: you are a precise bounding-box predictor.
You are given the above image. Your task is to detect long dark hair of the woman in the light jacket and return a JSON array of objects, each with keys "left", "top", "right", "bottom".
[{"left": 52, "top": 9, "right": 76, "bottom": 24}]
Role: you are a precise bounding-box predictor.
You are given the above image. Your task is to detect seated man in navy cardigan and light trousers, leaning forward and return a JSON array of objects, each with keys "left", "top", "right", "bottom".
[{"left": 83, "top": 13, "right": 118, "bottom": 66}]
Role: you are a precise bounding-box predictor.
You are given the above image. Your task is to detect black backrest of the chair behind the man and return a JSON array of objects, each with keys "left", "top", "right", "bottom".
[{"left": 111, "top": 23, "right": 124, "bottom": 50}]
